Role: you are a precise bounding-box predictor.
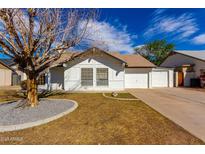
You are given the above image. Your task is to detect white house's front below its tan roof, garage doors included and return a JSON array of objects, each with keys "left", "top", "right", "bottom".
[{"left": 44, "top": 51, "right": 173, "bottom": 91}]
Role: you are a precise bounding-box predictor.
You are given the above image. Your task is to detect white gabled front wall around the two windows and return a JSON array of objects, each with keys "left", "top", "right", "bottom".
[{"left": 64, "top": 55, "right": 124, "bottom": 91}]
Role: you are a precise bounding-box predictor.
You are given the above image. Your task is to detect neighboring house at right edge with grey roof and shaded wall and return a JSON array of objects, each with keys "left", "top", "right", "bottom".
[{"left": 161, "top": 51, "right": 205, "bottom": 86}]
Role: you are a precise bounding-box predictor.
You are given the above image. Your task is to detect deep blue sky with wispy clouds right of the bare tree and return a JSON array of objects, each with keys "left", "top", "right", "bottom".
[{"left": 92, "top": 9, "right": 205, "bottom": 50}]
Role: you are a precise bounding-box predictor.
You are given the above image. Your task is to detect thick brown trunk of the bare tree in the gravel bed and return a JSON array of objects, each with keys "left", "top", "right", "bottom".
[{"left": 27, "top": 75, "right": 38, "bottom": 107}]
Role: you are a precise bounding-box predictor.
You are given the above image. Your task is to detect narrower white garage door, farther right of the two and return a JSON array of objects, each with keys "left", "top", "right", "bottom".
[{"left": 152, "top": 71, "right": 168, "bottom": 87}]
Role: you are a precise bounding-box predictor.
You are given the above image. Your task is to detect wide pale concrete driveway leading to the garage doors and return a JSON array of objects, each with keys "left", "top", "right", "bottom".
[{"left": 128, "top": 88, "right": 205, "bottom": 142}]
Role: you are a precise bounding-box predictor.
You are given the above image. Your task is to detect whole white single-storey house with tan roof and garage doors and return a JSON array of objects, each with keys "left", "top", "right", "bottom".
[{"left": 40, "top": 48, "right": 173, "bottom": 91}]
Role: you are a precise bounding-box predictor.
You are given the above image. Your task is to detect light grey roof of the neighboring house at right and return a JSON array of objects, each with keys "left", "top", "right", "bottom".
[{"left": 174, "top": 50, "right": 205, "bottom": 61}]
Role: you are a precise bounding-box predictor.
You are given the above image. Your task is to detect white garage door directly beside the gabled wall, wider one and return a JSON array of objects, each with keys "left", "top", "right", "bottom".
[{"left": 125, "top": 73, "right": 148, "bottom": 88}]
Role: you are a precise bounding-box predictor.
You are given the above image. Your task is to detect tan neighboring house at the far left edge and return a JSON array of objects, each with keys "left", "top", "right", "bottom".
[{"left": 0, "top": 60, "right": 12, "bottom": 86}]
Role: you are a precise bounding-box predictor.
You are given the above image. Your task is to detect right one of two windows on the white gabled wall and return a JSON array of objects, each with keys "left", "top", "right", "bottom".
[{"left": 96, "top": 68, "right": 108, "bottom": 86}]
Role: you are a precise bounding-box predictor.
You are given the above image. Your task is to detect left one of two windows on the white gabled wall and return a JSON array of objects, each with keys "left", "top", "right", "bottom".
[{"left": 81, "top": 68, "right": 93, "bottom": 86}]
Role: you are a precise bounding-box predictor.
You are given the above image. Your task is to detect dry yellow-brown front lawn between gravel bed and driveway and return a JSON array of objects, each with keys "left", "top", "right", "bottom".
[{"left": 0, "top": 93, "right": 204, "bottom": 144}]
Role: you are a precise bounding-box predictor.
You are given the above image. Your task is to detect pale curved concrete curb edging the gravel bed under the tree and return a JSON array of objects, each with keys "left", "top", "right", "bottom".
[{"left": 0, "top": 99, "right": 78, "bottom": 132}]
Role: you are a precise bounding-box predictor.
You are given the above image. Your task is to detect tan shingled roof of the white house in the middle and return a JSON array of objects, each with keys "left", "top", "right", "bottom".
[{"left": 54, "top": 47, "right": 156, "bottom": 68}]
